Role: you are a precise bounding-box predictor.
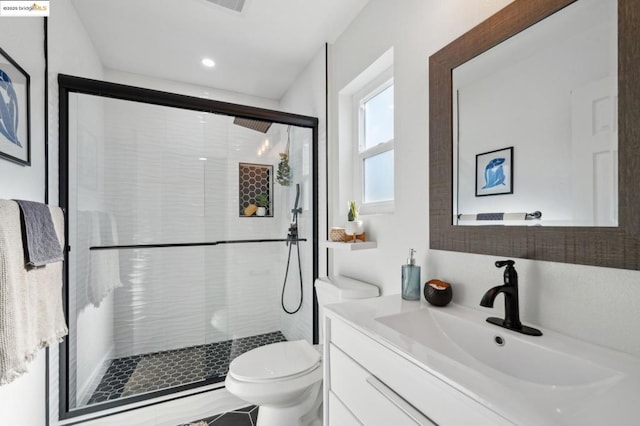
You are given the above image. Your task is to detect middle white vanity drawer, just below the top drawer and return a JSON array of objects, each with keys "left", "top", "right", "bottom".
[{"left": 329, "top": 345, "right": 433, "bottom": 426}]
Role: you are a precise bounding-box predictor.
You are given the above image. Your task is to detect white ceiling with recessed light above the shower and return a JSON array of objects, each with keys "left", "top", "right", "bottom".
[{"left": 72, "top": 0, "right": 369, "bottom": 100}]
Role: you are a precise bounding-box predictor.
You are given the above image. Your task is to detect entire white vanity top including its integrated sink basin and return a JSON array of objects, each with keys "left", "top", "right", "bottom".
[{"left": 327, "top": 295, "right": 640, "bottom": 426}]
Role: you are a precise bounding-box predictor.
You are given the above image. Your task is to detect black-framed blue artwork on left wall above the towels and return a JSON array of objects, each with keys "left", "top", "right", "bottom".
[{"left": 0, "top": 49, "right": 31, "bottom": 166}]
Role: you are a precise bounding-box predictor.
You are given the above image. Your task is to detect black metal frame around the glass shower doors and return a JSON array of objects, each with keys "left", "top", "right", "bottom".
[{"left": 58, "top": 74, "right": 319, "bottom": 424}]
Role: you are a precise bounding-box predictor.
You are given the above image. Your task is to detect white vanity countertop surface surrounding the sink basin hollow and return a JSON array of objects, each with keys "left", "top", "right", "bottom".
[{"left": 326, "top": 295, "right": 640, "bottom": 426}]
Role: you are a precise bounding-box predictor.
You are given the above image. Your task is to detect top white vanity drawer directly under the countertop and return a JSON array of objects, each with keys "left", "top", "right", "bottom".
[{"left": 329, "top": 317, "right": 513, "bottom": 426}]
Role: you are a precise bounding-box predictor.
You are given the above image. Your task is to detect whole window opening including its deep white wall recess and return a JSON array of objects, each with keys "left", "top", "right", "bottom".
[{"left": 338, "top": 47, "right": 395, "bottom": 218}]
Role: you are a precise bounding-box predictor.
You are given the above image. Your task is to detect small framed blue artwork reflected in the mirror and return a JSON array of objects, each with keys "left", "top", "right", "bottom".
[{"left": 476, "top": 146, "right": 513, "bottom": 197}]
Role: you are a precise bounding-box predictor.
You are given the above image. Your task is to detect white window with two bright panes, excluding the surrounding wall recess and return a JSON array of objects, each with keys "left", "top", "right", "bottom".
[{"left": 353, "top": 75, "right": 394, "bottom": 213}]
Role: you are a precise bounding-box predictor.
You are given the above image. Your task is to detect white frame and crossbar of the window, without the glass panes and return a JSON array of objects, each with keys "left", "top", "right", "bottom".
[{"left": 352, "top": 66, "right": 396, "bottom": 215}]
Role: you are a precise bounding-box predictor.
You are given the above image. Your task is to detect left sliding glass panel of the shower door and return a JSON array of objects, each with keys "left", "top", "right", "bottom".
[{"left": 68, "top": 94, "right": 218, "bottom": 407}]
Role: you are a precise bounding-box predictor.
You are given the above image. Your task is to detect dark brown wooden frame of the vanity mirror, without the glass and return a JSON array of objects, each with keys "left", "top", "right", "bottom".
[{"left": 429, "top": 0, "right": 640, "bottom": 270}]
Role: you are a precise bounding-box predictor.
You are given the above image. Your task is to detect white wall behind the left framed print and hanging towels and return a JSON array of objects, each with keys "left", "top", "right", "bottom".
[{"left": 0, "top": 17, "right": 49, "bottom": 425}]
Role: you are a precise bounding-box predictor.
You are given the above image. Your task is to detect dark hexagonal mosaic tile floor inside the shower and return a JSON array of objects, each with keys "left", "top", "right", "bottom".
[{"left": 88, "top": 331, "right": 286, "bottom": 404}]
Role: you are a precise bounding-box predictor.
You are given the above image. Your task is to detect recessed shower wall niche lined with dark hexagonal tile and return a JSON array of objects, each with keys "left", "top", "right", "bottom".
[{"left": 238, "top": 163, "right": 273, "bottom": 217}]
